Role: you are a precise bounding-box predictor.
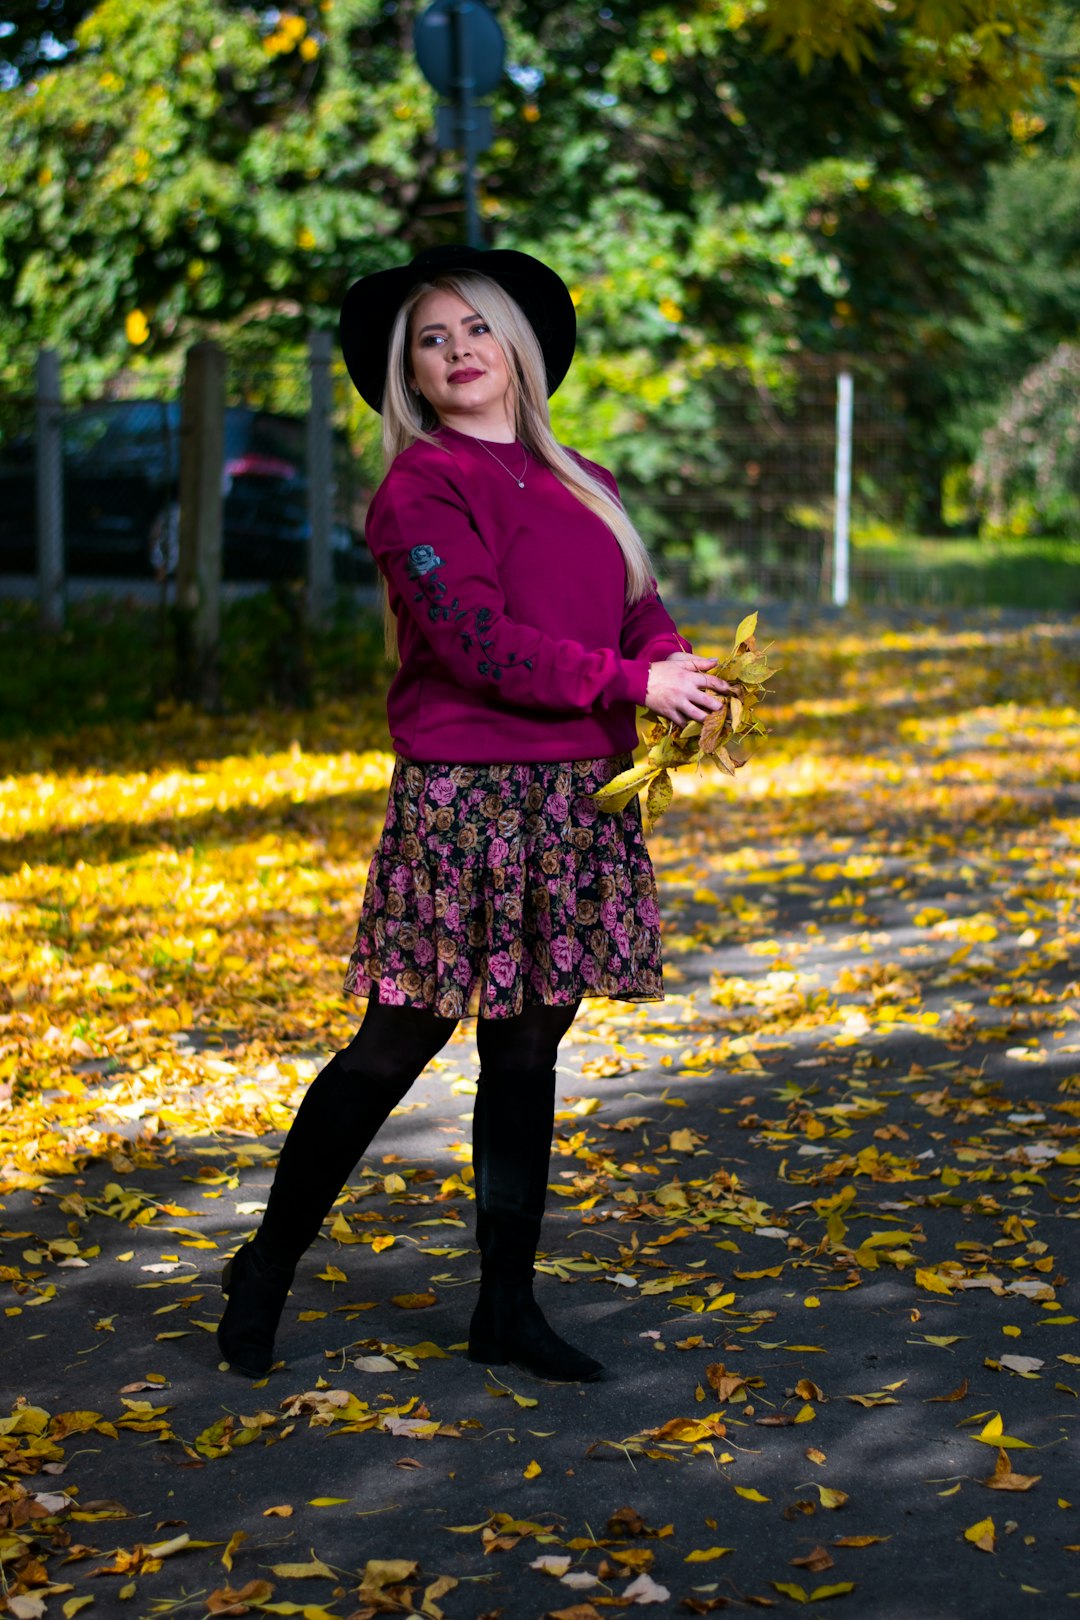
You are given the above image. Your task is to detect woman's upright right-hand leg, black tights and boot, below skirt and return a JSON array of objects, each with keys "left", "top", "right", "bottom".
[{"left": 470, "top": 1004, "right": 602, "bottom": 1382}]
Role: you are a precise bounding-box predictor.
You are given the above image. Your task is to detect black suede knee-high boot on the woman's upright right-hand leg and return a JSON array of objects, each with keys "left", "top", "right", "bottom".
[{"left": 468, "top": 1069, "right": 604, "bottom": 1383}]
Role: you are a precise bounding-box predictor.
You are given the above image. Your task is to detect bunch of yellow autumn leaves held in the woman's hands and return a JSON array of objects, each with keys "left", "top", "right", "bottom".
[{"left": 593, "top": 612, "right": 779, "bottom": 823}]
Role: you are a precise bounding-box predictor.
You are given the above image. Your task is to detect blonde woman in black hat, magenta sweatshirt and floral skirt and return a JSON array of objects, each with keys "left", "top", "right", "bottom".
[{"left": 219, "top": 246, "right": 727, "bottom": 1380}]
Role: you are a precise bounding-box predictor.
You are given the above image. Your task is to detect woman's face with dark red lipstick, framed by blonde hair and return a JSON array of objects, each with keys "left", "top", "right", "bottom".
[{"left": 408, "top": 290, "right": 515, "bottom": 441}]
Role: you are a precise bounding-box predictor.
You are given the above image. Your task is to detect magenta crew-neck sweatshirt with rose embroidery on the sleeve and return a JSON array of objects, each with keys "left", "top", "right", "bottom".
[{"left": 366, "top": 428, "right": 690, "bottom": 765}]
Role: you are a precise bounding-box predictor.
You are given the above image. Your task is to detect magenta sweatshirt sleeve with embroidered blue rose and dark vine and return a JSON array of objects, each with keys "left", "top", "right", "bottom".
[{"left": 368, "top": 465, "right": 649, "bottom": 713}]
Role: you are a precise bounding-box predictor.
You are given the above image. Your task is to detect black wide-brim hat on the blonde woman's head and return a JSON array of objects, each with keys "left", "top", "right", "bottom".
[{"left": 340, "top": 243, "right": 578, "bottom": 411}]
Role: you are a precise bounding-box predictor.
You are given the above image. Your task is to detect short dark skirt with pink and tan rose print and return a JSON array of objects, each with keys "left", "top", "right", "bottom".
[{"left": 345, "top": 755, "right": 664, "bottom": 1017}]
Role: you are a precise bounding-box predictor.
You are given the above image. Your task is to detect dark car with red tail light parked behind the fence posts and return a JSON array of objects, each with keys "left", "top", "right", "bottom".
[{"left": 0, "top": 400, "right": 374, "bottom": 582}]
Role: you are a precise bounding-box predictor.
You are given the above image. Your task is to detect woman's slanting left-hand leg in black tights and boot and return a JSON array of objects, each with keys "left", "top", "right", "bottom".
[{"left": 217, "top": 1000, "right": 457, "bottom": 1377}]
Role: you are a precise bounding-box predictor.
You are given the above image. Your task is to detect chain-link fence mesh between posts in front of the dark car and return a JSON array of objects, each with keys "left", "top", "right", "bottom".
[{"left": 0, "top": 355, "right": 374, "bottom": 601}]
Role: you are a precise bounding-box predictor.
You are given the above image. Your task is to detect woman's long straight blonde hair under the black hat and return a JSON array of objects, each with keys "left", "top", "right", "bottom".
[{"left": 375, "top": 271, "right": 653, "bottom": 661}]
